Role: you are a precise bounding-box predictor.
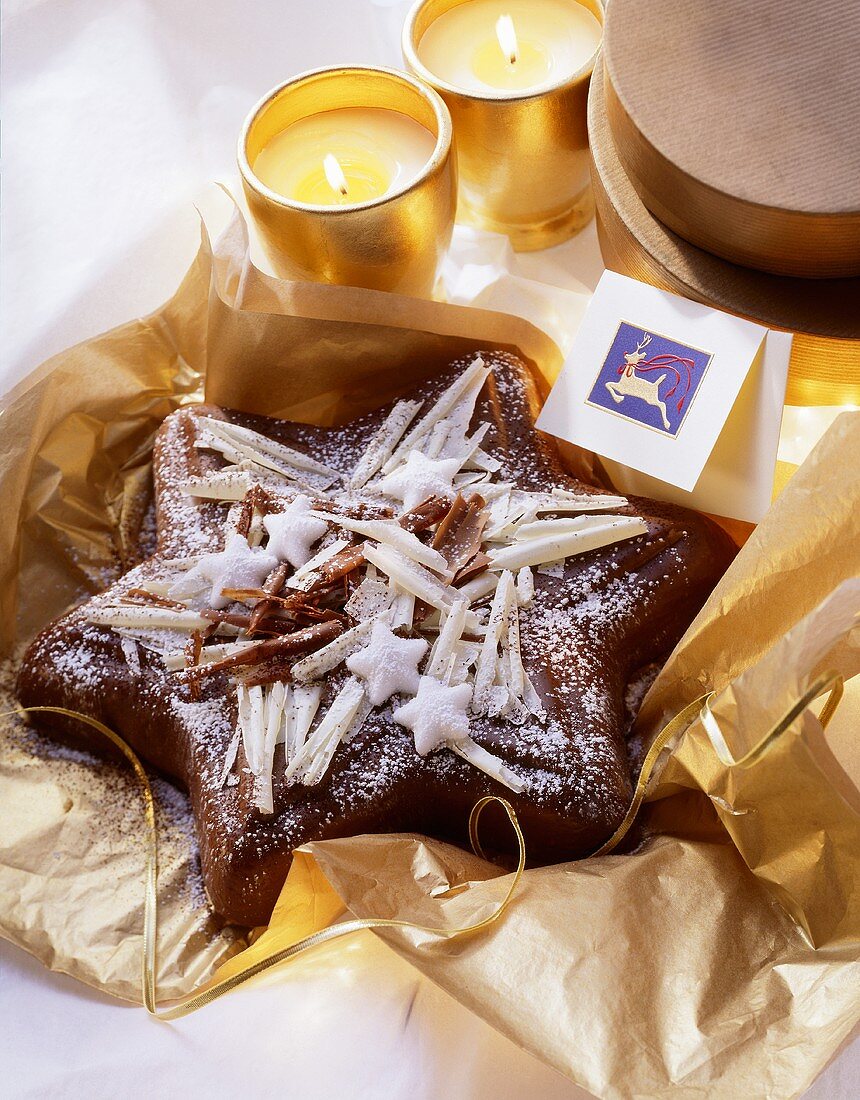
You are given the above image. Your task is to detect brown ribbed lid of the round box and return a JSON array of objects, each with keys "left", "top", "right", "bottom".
[{"left": 604, "top": 0, "right": 860, "bottom": 278}]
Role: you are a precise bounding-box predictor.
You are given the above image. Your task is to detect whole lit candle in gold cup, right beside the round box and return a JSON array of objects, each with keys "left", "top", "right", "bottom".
[{"left": 403, "top": 0, "right": 603, "bottom": 251}]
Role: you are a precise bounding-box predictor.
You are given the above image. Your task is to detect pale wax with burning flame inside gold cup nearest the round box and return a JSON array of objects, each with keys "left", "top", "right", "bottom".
[{"left": 418, "top": 0, "right": 602, "bottom": 94}]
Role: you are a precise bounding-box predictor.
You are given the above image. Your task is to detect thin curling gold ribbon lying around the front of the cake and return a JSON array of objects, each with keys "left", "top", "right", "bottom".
[{"left": 10, "top": 672, "right": 842, "bottom": 1020}]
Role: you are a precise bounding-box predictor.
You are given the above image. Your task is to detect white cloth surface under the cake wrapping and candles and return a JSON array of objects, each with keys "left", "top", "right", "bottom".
[{"left": 0, "top": 0, "right": 860, "bottom": 1100}]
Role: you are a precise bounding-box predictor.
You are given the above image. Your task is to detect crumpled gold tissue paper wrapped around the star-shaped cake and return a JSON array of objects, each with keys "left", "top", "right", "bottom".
[{"left": 0, "top": 204, "right": 860, "bottom": 1098}]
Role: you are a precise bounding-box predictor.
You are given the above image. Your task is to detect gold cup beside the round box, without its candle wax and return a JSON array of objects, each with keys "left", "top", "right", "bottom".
[{"left": 403, "top": 0, "right": 604, "bottom": 252}]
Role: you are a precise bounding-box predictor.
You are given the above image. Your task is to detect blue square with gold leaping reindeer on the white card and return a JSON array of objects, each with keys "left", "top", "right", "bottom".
[{"left": 586, "top": 321, "right": 714, "bottom": 437}]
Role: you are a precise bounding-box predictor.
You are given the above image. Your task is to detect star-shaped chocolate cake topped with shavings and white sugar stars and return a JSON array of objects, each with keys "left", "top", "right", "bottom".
[{"left": 19, "top": 353, "right": 734, "bottom": 924}]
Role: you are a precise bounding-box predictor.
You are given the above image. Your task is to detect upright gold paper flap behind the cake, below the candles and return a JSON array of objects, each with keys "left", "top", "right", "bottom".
[{"left": 206, "top": 215, "right": 562, "bottom": 425}]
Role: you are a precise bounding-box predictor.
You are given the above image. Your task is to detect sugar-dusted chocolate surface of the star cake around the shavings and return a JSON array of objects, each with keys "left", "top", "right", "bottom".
[{"left": 15, "top": 354, "right": 725, "bottom": 913}]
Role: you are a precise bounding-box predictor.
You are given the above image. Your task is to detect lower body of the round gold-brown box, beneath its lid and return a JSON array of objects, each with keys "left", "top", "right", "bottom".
[{"left": 588, "top": 54, "right": 860, "bottom": 405}]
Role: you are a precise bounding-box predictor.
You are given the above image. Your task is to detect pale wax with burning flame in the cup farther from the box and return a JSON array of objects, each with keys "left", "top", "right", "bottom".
[{"left": 253, "top": 107, "right": 435, "bottom": 206}]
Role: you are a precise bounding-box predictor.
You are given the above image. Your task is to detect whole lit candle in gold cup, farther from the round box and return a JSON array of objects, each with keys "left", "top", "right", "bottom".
[{"left": 239, "top": 66, "right": 456, "bottom": 295}]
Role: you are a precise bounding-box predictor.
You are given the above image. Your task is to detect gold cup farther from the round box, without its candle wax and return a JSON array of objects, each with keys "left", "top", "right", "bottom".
[{"left": 239, "top": 67, "right": 456, "bottom": 296}]
